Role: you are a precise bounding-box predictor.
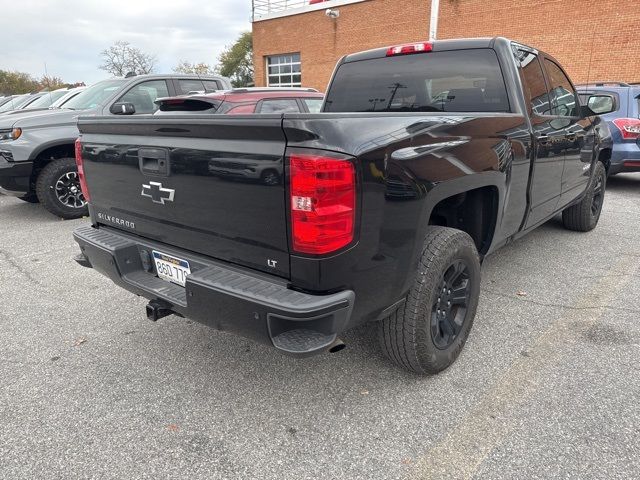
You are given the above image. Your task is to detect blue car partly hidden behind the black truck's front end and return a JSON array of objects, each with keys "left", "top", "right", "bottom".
[{"left": 577, "top": 82, "right": 640, "bottom": 175}]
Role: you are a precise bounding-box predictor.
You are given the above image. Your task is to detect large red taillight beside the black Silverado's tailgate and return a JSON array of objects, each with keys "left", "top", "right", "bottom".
[{"left": 289, "top": 153, "right": 356, "bottom": 255}]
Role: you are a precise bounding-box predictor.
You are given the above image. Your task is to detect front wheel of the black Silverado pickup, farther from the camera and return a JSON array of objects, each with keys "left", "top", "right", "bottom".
[{"left": 562, "top": 162, "right": 607, "bottom": 232}]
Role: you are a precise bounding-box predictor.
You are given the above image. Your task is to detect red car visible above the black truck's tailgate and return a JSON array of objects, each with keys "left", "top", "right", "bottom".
[{"left": 156, "top": 88, "right": 324, "bottom": 115}]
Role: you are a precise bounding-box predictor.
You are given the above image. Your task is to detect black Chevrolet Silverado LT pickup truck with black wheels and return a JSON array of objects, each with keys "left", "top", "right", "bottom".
[{"left": 74, "top": 38, "right": 610, "bottom": 373}]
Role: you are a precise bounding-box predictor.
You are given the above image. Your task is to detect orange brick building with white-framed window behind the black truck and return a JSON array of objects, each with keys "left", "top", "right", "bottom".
[{"left": 253, "top": 0, "right": 640, "bottom": 91}]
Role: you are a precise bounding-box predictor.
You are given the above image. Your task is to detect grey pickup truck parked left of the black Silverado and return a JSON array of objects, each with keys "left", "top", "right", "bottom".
[{"left": 0, "top": 74, "right": 231, "bottom": 218}]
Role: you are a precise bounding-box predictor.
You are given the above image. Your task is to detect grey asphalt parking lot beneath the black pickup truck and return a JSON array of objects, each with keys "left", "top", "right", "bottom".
[{"left": 0, "top": 174, "right": 640, "bottom": 479}]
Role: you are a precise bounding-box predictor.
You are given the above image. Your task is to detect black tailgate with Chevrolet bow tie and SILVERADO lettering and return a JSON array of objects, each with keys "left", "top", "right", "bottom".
[{"left": 79, "top": 115, "right": 289, "bottom": 278}]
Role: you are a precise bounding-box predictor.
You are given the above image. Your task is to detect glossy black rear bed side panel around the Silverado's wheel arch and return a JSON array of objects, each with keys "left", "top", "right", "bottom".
[{"left": 283, "top": 113, "right": 530, "bottom": 320}]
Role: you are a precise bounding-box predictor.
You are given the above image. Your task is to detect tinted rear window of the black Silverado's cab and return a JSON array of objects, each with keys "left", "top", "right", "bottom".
[{"left": 324, "top": 49, "right": 510, "bottom": 112}]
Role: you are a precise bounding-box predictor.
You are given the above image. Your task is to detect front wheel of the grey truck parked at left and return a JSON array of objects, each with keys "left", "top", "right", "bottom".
[{"left": 36, "top": 158, "right": 89, "bottom": 220}]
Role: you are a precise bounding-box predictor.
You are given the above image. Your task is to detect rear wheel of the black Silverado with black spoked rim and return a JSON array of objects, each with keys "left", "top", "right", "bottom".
[{"left": 378, "top": 227, "right": 480, "bottom": 375}]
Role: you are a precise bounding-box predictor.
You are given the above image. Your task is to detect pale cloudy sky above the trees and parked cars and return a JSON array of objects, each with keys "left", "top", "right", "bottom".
[{"left": 0, "top": 0, "right": 251, "bottom": 84}]
